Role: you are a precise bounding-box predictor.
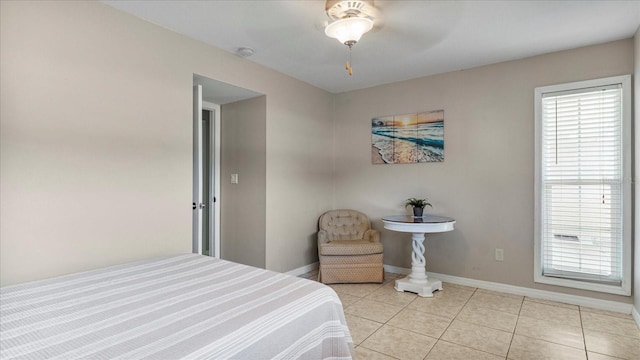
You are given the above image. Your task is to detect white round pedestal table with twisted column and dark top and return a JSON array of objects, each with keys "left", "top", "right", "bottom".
[{"left": 382, "top": 215, "right": 456, "bottom": 297}]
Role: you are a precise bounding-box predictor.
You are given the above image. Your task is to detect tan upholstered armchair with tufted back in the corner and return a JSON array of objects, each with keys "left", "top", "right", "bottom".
[{"left": 318, "top": 210, "right": 384, "bottom": 284}]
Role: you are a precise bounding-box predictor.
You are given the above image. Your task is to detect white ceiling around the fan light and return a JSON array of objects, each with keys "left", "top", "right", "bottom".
[{"left": 103, "top": 0, "right": 640, "bottom": 92}]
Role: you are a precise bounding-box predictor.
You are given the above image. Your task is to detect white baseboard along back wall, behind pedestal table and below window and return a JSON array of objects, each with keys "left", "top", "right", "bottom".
[{"left": 384, "top": 265, "right": 640, "bottom": 316}]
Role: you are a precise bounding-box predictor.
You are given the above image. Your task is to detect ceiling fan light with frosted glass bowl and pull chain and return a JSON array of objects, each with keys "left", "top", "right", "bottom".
[{"left": 324, "top": 0, "right": 381, "bottom": 75}]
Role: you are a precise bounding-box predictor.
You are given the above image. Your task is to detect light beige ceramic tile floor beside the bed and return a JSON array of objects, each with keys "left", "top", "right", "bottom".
[{"left": 302, "top": 272, "right": 640, "bottom": 360}]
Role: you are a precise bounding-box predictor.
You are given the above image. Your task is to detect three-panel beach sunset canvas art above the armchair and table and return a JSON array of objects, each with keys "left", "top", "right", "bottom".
[{"left": 371, "top": 110, "right": 444, "bottom": 164}]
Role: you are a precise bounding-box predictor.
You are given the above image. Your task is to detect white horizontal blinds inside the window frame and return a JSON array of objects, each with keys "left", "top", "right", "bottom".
[{"left": 539, "top": 84, "right": 624, "bottom": 286}]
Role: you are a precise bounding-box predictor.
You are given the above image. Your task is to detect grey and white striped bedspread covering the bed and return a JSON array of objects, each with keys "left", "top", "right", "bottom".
[{"left": 0, "top": 254, "right": 353, "bottom": 360}]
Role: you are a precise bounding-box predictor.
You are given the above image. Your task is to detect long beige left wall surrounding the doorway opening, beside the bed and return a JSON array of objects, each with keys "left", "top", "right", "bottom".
[{"left": 0, "top": 1, "right": 332, "bottom": 285}]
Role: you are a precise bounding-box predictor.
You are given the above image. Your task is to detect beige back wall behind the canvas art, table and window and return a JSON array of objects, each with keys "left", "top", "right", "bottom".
[{"left": 334, "top": 40, "right": 633, "bottom": 303}]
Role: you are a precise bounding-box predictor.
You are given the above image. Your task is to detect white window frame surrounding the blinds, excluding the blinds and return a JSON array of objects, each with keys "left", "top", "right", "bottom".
[{"left": 534, "top": 75, "right": 633, "bottom": 296}]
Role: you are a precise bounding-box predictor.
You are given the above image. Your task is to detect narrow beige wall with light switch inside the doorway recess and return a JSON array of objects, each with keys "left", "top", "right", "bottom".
[{"left": 220, "top": 96, "right": 267, "bottom": 268}]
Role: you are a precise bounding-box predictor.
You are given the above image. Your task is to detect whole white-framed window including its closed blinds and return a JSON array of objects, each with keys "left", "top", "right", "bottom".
[{"left": 534, "top": 75, "right": 631, "bottom": 295}]
